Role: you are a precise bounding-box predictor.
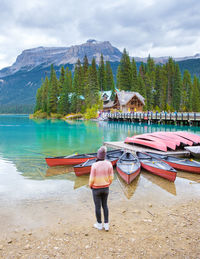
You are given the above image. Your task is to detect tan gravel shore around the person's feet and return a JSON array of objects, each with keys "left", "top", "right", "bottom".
[{"left": 0, "top": 198, "right": 200, "bottom": 259}]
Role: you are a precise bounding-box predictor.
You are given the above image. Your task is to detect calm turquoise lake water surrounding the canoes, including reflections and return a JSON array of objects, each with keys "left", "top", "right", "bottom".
[{"left": 0, "top": 115, "right": 200, "bottom": 206}]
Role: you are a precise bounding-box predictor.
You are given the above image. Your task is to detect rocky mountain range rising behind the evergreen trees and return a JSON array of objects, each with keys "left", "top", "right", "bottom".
[{"left": 0, "top": 40, "right": 200, "bottom": 112}]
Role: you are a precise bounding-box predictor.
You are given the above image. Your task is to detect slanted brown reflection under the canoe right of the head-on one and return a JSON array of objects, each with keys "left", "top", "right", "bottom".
[{"left": 142, "top": 170, "right": 176, "bottom": 195}]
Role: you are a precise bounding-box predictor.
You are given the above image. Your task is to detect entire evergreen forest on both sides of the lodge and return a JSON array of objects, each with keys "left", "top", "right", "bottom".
[{"left": 35, "top": 49, "right": 200, "bottom": 115}]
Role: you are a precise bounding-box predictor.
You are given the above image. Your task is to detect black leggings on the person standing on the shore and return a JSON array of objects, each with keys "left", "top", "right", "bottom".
[{"left": 92, "top": 187, "right": 109, "bottom": 223}]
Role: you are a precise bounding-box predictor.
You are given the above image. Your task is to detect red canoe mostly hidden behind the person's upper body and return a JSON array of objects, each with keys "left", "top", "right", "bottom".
[{"left": 74, "top": 157, "right": 119, "bottom": 176}]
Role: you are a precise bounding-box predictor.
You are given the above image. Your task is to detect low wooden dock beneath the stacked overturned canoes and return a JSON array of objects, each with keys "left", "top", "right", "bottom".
[{"left": 104, "top": 141, "right": 190, "bottom": 157}]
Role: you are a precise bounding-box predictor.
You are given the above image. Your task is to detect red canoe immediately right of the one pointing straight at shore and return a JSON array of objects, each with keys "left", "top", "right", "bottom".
[{"left": 136, "top": 152, "right": 176, "bottom": 182}]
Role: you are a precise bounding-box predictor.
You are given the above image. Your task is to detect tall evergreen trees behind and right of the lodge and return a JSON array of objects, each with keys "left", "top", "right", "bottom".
[{"left": 117, "top": 50, "right": 200, "bottom": 111}]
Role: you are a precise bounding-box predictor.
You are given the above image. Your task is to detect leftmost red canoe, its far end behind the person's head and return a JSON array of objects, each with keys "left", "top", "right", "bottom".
[{"left": 45, "top": 149, "right": 123, "bottom": 166}]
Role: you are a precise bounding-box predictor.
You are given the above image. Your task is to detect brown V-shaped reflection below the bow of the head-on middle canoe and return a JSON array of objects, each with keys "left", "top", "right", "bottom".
[{"left": 116, "top": 173, "right": 140, "bottom": 199}]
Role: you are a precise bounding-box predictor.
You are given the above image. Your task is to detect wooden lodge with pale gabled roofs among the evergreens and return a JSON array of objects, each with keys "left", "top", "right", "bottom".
[{"left": 102, "top": 91, "right": 145, "bottom": 112}]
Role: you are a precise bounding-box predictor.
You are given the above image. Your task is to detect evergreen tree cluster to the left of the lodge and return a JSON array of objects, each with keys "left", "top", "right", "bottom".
[{"left": 35, "top": 55, "right": 115, "bottom": 115}]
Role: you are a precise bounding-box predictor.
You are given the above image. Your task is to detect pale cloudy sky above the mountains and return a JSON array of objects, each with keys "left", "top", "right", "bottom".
[{"left": 0, "top": 0, "right": 200, "bottom": 68}]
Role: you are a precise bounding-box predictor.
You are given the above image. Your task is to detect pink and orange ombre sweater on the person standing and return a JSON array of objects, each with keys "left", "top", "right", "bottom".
[{"left": 89, "top": 160, "right": 114, "bottom": 189}]
